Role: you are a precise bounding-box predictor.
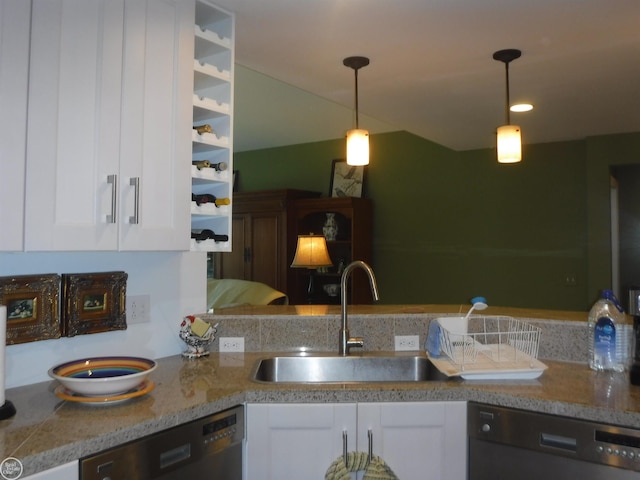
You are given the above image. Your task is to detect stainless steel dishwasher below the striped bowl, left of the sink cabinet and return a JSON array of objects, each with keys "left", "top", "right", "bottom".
[{"left": 80, "top": 406, "right": 244, "bottom": 480}]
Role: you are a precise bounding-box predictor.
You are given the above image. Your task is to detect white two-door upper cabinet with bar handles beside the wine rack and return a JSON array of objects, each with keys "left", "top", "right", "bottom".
[{"left": 25, "top": 0, "right": 195, "bottom": 251}]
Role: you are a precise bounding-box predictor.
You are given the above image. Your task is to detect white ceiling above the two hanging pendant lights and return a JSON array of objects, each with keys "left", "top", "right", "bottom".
[{"left": 215, "top": 0, "right": 640, "bottom": 151}]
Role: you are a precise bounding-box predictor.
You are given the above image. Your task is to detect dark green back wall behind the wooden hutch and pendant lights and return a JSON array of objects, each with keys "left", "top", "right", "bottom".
[{"left": 234, "top": 132, "right": 640, "bottom": 310}]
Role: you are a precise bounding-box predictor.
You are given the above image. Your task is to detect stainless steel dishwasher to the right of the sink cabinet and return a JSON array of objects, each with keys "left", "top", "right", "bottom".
[{"left": 468, "top": 402, "right": 640, "bottom": 480}]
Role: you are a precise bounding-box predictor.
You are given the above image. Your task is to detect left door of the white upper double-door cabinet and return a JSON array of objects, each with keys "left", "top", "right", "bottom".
[{"left": 25, "top": 0, "right": 124, "bottom": 250}]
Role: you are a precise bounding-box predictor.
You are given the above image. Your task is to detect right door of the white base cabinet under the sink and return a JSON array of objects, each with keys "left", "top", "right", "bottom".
[{"left": 358, "top": 402, "right": 467, "bottom": 480}]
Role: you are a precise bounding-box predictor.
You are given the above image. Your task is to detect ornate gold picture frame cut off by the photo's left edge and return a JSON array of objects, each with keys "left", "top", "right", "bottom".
[{"left": 0, "top": 273, "right": 62, "bottom": 345}]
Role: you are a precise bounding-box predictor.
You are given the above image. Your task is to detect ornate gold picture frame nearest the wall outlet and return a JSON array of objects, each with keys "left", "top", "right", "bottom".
[{"left": 62, "top": 272, "right": 127, "bottom": 337}]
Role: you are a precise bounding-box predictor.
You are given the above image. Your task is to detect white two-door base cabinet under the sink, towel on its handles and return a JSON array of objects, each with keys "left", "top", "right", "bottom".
[{"left": 245, "top": 402, "right": 467, "bottom": 480}]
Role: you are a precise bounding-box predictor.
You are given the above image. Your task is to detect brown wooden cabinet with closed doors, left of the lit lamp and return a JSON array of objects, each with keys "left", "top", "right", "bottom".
[{"left": 215, "top": 190, "right": 320, "bottom": 294}]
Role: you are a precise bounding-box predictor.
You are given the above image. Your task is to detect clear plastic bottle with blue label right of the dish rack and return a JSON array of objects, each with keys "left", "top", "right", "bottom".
[{"left": 589, "top": 290, "right": 630, "bottom": 372}]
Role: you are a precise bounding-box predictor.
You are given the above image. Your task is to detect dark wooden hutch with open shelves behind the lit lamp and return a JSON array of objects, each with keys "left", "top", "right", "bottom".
[{"left": 287, "top": 197, "right": 373, "bottom": 304}]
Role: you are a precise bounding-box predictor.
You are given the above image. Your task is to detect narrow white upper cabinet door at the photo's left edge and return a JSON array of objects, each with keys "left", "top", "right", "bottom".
[{"left": 0, "top": 0, "right": 31, "bottom": 251}]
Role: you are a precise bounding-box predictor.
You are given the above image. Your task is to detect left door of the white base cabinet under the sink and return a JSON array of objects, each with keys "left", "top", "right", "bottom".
[{"left": 244, "top": 403, "right": 356, "bottom": 480}]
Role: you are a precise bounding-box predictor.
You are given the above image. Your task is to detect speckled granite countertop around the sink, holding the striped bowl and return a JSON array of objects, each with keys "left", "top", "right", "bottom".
[{"left": 0, "top": 352, "right": 640, "bottom": 475}]
